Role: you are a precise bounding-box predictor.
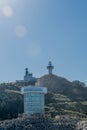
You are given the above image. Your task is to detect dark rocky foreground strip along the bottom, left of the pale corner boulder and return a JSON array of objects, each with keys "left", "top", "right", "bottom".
[{"left": 0, "top": 117, "right": 76, "bottom": 130}]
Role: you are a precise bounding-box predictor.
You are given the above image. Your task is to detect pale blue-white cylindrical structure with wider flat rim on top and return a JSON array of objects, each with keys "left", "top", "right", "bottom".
[{"left": 21, "top": 86, "right": 47, "bottom": 114}]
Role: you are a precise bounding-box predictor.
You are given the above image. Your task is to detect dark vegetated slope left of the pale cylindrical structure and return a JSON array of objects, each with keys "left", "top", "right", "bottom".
[{"left": 0, "top": 83, "right": 23, "bottom": 120}]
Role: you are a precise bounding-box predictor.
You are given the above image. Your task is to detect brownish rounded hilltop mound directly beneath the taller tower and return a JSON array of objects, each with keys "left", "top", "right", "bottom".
[{"left": 38, "top": 74, "right": 72, "bottom": 93}]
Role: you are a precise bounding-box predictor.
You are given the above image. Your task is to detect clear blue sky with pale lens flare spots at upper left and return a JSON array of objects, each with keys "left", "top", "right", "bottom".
[{"left": 0, "top": 0, "right": 87, "bottom": 84}]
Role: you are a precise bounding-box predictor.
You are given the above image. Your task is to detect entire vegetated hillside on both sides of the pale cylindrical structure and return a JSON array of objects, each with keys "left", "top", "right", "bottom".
[{"left": 0, "top": 74, "right": 87, "bottom": 120}]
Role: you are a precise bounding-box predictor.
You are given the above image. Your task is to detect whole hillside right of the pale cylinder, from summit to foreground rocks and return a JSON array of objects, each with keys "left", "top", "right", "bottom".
[{"left": 37, "top": 74, "right": 87, "bottom": 115}]
